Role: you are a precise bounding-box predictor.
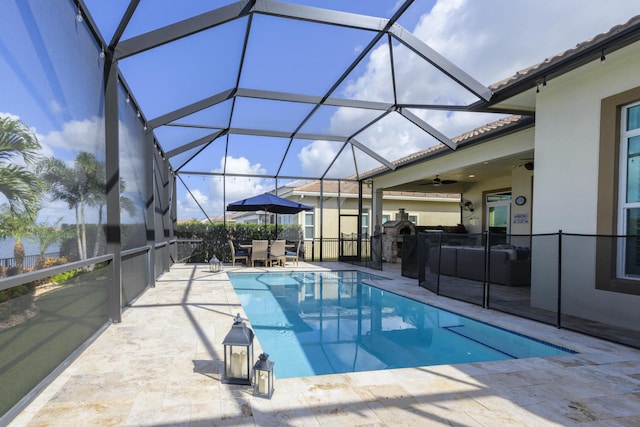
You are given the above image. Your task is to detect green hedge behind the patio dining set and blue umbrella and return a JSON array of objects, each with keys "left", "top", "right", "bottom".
[{"left": 176, "top": 221, "right": 303, "bottom": 263}]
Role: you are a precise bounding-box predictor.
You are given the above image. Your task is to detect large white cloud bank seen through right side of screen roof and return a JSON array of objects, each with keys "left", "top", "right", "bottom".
[{"left": 300, "top": 0, "right": 638, "bottom": 175}]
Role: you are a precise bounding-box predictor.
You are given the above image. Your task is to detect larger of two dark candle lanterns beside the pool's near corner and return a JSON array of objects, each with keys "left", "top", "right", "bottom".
[{"left": 222, "top": 313, "right": 254, "bottom": 385}]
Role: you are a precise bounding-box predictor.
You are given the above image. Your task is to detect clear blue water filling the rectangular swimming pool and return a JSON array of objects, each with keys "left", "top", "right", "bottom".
[{"left": 229, "top": 271, "right": 573, "bottom": 378}]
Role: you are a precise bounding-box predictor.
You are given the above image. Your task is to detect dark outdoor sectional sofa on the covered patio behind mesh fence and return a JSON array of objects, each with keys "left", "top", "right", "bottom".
[{"left": 429, "top": 245, "right": 531, "bottom": 286}]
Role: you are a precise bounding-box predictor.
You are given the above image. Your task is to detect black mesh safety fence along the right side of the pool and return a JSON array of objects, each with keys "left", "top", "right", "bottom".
[{"left": 416, "top": 232, "right": 640, "bottom": 348}]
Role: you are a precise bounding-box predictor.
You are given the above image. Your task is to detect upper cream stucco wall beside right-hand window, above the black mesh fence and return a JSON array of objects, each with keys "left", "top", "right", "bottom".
[{"left": 533, "top": 43, "right": 640, "bottom": 233}]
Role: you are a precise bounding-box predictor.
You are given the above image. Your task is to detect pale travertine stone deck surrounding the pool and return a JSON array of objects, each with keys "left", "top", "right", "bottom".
[{"left": 10, "top": 263, "right": 640, "bottom": 427}]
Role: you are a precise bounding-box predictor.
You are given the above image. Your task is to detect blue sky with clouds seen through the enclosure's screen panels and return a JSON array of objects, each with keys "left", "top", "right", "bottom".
[{"left": 0, "top": 0, "right": 640, "bottom": 224}]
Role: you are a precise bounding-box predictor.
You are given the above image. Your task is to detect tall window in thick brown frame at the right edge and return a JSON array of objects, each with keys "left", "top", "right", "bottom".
[{"left": 617, "top": 103, "right": 640, "bottom": 278}]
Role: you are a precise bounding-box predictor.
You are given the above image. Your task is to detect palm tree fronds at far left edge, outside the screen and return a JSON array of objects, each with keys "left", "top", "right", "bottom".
[{"left": 0, "top": 117, "right": 42, "bottom": 216}]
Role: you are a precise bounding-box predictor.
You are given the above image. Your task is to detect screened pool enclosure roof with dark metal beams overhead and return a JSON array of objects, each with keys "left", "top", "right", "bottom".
[{"left": 84, "top": 0, "right": 507, "bottom": 186}]
